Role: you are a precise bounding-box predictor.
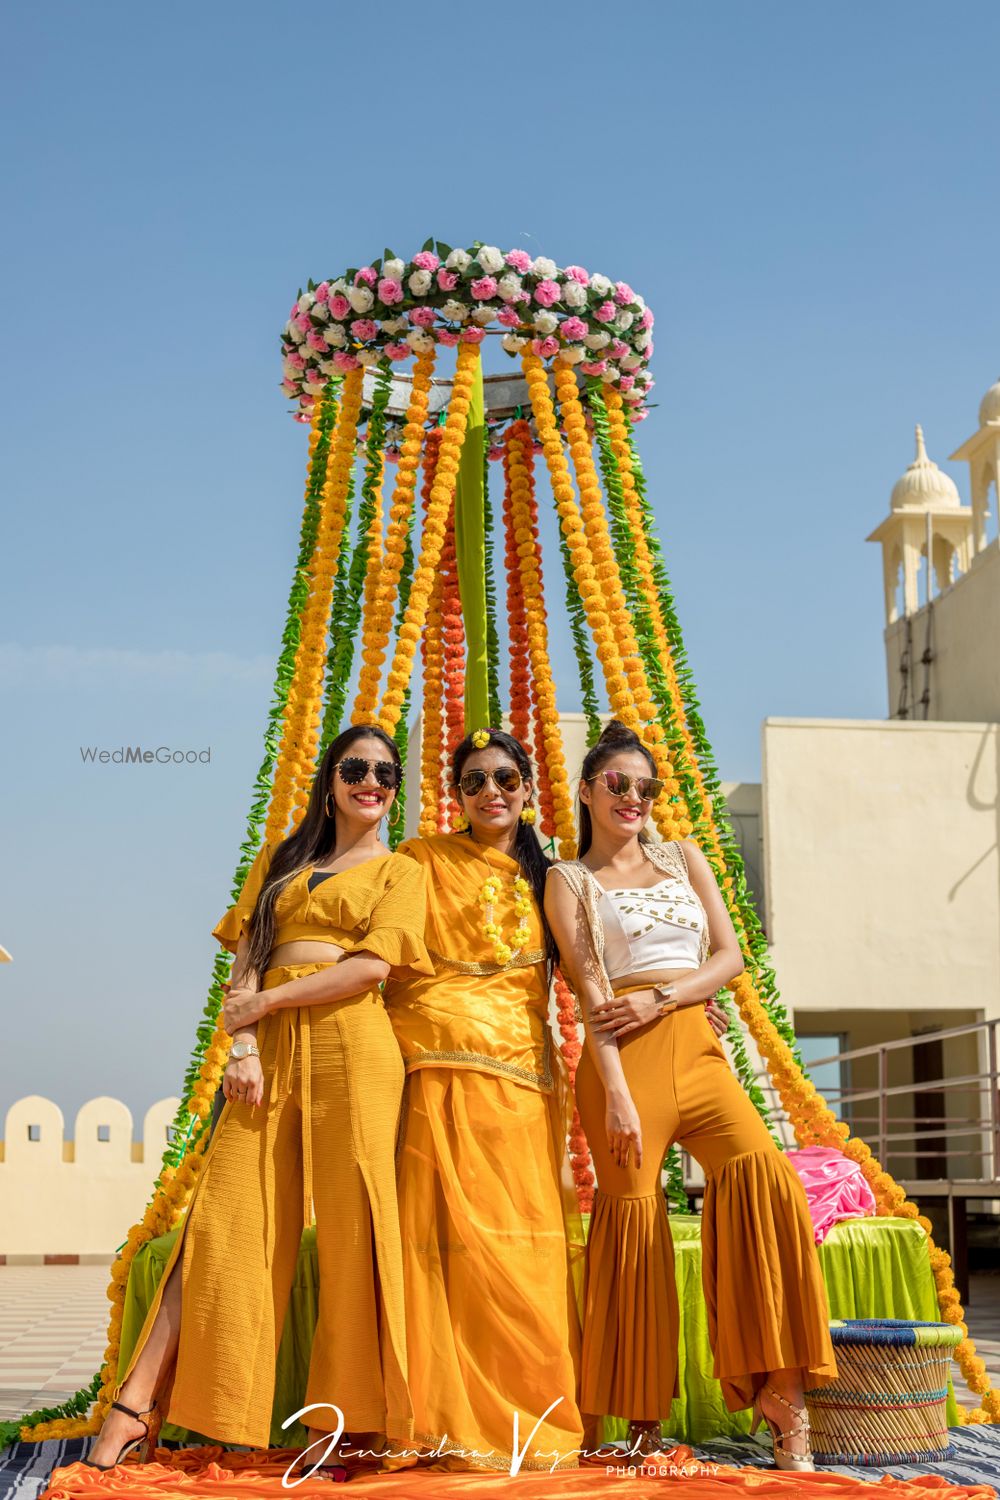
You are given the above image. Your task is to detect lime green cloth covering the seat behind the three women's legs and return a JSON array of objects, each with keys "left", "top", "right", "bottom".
[{"left": 118, "top": 1214, "right": 957, "bottom": 1448}]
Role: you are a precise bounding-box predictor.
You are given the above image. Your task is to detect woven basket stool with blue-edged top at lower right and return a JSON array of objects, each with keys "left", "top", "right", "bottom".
[{"left": 805, "top": 1317, "right": 963, "bottom": 1466}]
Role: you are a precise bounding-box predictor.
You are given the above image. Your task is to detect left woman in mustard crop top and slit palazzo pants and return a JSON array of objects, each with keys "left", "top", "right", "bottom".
[{"left": 83, "top": 726, "right": 433, "bottom": 1466}]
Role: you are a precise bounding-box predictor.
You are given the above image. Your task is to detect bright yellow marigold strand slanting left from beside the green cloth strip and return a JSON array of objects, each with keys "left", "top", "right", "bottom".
[{"left": 378, "top": 344, "right": 480, "bottom": 735}]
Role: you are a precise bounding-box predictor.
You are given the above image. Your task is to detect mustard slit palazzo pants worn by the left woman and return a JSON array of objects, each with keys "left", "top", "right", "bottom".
[{"left": 121, "top": 963, "right": 412, "bottom": 1448}]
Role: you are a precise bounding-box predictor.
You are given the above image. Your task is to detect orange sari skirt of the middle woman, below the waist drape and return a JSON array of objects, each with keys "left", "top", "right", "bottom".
[{"left": 399, "top": 1068, "right": 583, "bottom": 1470}]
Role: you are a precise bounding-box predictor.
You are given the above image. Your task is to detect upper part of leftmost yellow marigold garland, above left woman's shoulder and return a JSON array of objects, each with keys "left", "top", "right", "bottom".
[{"left": 264, "top": 368, "right": 364, "bottom": 839}]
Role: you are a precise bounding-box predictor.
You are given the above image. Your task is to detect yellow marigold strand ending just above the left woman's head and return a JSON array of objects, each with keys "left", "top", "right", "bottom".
[{"left": 351, "top": 350, "right": 436, "bottom": 725}]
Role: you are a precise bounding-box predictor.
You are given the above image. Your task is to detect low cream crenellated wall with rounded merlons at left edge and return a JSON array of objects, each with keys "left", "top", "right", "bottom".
[{"left": 0, "top": 1094, "right": 178, "bottom": 1263}]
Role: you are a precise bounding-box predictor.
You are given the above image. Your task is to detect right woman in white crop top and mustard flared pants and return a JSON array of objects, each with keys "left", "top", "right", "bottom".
[{"left": 546, "top": 720, "right": 837, "bottom": 1472}]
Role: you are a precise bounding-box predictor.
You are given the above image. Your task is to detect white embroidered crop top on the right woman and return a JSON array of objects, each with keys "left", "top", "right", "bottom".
[{"left": 598, "top": 875, "right": 705, "bottom": 981}]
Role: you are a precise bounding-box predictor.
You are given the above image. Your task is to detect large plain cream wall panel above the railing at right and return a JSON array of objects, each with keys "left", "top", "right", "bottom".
[{"left": 763, "top": 719, "right": 1000, "bottom": 1025}]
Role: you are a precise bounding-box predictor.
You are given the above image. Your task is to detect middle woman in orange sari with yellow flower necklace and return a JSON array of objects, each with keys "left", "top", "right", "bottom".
[{"left": 385, "top": 731, "right": 583, "bottom": 1472}]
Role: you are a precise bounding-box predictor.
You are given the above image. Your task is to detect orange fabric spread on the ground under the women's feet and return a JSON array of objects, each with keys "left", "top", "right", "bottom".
[{"left": 40, "top": 1446, "right": 997, "bottom": 1500}]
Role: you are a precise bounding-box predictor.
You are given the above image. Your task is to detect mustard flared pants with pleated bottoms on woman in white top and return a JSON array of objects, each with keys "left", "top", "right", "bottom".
[{"left": 576, "top": 1005, "right": 837, "bottom": 1421}]
